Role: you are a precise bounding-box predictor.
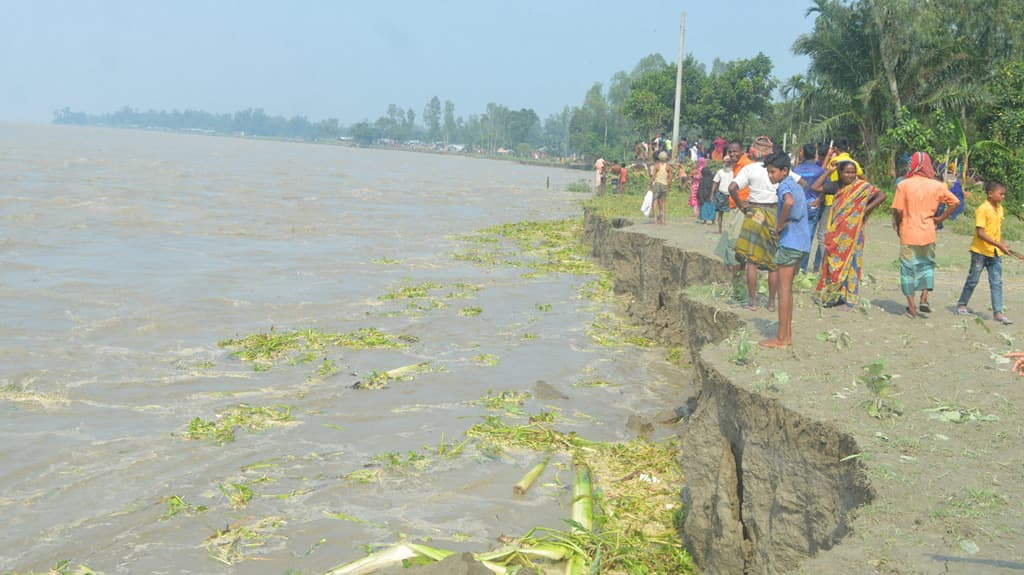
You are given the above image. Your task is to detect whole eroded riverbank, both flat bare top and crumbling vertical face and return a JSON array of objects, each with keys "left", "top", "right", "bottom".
[{"left": 584, "top": 210, "right": 1024, "bottom": 574}]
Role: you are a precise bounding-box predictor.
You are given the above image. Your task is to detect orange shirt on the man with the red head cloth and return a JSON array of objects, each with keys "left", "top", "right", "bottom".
[{"left": 893, "top": 176, "right": 959, "bottom": 246}]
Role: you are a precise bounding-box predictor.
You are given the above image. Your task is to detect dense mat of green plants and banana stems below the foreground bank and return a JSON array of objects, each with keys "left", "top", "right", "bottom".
[{"left": 328, "top": 407, "right": 694, "bottom": 575}]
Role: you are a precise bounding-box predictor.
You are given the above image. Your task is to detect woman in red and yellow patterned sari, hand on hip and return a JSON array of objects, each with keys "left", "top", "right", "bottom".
[{"left": 818, "top": 162, "right": 886, "bottom": 307}]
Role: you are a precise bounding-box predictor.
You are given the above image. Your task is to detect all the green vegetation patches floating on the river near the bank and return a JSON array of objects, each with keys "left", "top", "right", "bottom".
[{"left": 192, "top": 212, "right": 693, "bottom": 575}]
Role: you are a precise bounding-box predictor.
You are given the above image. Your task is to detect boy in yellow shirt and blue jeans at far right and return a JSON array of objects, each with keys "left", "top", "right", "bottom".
[{"left": 956, "top": 181, "right": 1024, "bottom": 325}]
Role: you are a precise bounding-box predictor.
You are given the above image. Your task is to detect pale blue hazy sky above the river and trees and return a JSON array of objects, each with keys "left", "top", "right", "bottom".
[{"left": 0, "top": 0, "right": 813, "bottom": 125}]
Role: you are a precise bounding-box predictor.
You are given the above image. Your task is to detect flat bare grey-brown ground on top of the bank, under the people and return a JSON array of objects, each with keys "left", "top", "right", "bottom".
[{"left": 633, "top": 215, "right": 1024, "bottom": 574}]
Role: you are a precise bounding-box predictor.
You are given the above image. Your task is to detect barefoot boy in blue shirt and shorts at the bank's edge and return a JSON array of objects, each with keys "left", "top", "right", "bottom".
[{"left": 759, "top": 151, "right": 811, "bottom": 348}]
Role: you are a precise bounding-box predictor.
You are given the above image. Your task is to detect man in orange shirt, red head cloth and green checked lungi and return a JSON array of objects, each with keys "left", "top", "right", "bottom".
[{"left": 893, "top": 151, "right": 959, "bottom": 318}]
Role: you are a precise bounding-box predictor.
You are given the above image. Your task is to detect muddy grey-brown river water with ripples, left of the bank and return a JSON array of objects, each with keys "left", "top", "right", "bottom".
[{"left": 0, "top": 125, "right": 683, "bottom": 574}]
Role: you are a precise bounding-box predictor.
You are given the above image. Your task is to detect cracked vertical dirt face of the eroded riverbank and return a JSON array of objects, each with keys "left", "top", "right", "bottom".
[{"left": 584, "top": 213, "right": 873, "bottom": 574}]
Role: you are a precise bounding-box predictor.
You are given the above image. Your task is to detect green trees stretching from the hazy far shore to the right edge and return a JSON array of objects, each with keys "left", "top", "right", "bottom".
[{"left": 54, "top": 0, "right": 1024, "bottom": 207}]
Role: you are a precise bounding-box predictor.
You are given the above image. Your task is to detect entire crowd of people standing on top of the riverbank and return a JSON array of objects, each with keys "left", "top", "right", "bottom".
[{"left": 595, "top": 134, "right": 1024, "bottom": 348}]
